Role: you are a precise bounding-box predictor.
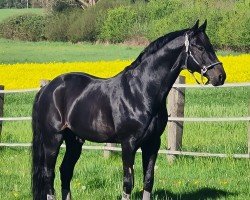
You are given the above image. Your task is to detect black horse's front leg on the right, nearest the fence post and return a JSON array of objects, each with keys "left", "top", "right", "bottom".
[{"left": 141, "top": 137, "right": 161, "bottom": 200}]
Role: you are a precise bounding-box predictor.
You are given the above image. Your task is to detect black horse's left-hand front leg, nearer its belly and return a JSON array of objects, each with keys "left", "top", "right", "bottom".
[{"left": 122, "top": 143, "right": 136, "bottom": 200}]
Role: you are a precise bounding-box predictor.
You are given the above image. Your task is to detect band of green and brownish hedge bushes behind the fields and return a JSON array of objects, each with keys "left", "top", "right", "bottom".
[{"left": 0, "top": 0, "right": 250, "bottom": 51}]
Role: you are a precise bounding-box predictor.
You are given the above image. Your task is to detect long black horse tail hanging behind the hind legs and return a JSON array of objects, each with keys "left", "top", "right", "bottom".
[{"left": 31, "top": 88, "right": 45, "bottom": 200}]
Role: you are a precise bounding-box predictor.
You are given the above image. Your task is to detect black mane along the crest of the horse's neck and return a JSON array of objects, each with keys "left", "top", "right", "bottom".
[{"left": 125, "top": 29, "right": 189, "bottom": 71}]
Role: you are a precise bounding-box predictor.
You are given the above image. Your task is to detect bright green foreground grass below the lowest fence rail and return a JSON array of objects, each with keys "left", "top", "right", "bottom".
[{"left": 0, "top": 148, "right": 250, "bottom": 200}]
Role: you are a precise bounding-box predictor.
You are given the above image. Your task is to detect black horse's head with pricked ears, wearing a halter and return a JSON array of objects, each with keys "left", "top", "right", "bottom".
[{"left": 185, "top": 20, "right": 226, "bottom": 86}]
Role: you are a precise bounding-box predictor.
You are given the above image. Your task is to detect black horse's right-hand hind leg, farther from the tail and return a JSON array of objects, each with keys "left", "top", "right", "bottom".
[{"left": 60, "top": 129, "right": 84, "bottom": 200}]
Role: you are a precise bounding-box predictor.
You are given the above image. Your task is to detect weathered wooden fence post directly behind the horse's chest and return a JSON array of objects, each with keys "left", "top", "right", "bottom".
[{"left": 167, "top": 76, "right": 185, "bottom": 162}]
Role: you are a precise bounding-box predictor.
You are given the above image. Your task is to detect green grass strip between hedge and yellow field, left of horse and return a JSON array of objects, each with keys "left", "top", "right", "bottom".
[{"left": 0, "top": 39, "right": 142, "bottom": 64}]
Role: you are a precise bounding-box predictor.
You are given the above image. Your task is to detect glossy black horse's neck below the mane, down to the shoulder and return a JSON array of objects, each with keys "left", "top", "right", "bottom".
[{"left": 125, "top": 44, "right": 183, "bottom": 104}]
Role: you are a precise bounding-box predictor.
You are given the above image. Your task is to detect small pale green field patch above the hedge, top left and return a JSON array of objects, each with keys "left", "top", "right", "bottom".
[{"left": 0, "top": 8, "right": 44, "bottom": 22}]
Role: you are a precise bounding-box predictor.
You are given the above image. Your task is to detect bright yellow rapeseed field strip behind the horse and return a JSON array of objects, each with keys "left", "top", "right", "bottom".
[{"left": 0, "top": 54, "right": 250, "bottom": 89}]
